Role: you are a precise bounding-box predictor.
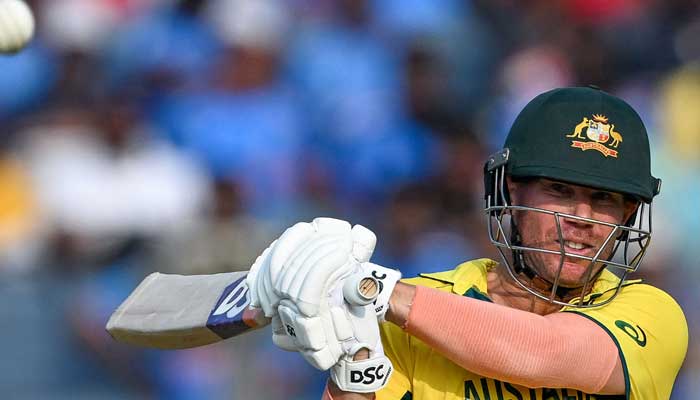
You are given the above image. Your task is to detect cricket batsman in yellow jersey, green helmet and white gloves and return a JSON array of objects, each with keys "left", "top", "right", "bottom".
[{"left": 248, "top": 87, "right": 688, "bottom": 400}]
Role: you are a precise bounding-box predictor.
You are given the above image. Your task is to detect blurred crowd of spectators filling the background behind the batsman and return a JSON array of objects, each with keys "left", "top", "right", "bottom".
[{"left": 0, "top": 0, "right": 700, "bottom": 400}]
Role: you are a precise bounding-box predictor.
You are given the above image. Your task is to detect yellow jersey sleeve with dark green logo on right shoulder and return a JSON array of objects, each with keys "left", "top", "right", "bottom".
[{"left": 567, "top": 284, "right": 688, "bottom": 400}]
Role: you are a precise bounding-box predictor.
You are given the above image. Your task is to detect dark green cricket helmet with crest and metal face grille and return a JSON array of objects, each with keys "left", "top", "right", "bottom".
[{"left": 484, "top": 87, "right": 661, "bottom": 307}]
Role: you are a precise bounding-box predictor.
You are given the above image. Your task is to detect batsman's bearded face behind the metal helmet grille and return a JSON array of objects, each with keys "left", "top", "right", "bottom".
[{"left": 508, "top": 179, "right": 636, "bottom": 288}]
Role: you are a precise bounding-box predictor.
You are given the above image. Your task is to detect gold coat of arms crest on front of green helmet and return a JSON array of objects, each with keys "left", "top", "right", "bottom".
[{"left": 566, "top": 114, "right": 622, "bottom": 158}]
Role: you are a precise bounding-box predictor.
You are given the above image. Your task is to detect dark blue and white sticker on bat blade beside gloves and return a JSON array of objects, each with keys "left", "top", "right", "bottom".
[{"left": 207, "top": 277, "right": 258, "bottom": 339}]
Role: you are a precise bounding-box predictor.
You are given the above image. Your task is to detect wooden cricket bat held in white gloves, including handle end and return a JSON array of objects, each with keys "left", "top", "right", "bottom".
[{"left": 106, "top": 271, "right": 379, "bottom": 349}]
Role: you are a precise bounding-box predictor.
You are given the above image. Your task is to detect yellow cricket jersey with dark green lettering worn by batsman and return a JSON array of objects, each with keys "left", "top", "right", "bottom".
[{"left": 377, "top": 259, "right": 688, "bottom": 400}]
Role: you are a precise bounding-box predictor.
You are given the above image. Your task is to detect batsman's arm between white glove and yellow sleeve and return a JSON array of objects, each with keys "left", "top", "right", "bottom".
[{"left": 387, "top": 284, "right": 624, "bottom": 394}]
